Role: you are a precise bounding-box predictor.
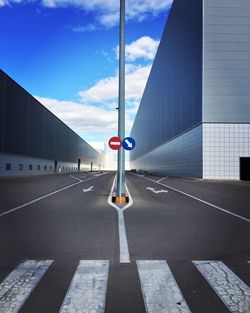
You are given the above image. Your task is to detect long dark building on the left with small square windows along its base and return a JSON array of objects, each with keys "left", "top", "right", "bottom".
[{"left": 0, "top": 70, "right": 101, "bottom": 176}]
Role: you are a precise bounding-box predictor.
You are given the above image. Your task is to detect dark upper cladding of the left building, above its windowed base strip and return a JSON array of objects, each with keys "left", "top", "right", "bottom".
[{"left": 0, "top": 70, "right": 100, "bottom": 168}]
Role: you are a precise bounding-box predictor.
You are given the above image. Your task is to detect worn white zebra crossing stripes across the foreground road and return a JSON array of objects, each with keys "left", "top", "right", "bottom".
[{"left": 0, "top": 260, "right": 250, "bottom": 313}]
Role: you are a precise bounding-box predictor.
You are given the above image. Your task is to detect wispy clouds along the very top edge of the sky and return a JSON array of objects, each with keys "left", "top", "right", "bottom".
[{"left": 0, "top": 0, "right": 173, "bottom": 27}]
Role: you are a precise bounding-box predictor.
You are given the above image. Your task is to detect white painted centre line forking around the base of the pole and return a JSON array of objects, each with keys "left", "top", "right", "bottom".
[{"left": 108, "top": 176, "right": 133, "bottom": 263}]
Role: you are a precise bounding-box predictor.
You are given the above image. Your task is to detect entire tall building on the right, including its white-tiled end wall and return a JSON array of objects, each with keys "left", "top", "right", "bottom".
[{"left": 130, "top": 0, "right": 250, "bottom": 180}]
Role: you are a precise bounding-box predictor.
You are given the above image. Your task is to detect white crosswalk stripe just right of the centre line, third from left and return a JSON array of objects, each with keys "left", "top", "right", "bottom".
[{"left": 136, "top": 261, "right": 191, "bottom": 313}]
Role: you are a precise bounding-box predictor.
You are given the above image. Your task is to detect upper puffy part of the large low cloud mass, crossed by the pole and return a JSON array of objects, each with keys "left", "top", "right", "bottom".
[{"left": 79, "top": 64, "right": 151, "bottom": 103}]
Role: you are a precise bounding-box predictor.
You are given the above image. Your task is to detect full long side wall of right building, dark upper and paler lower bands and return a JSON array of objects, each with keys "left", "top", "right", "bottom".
[{"left": 130, "top": 0, "right": 203, "bottom": 177}]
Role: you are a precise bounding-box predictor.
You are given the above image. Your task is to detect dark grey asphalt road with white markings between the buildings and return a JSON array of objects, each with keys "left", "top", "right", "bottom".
[{"left": 0, "top": 173, "right": 250, "bottom": 313}]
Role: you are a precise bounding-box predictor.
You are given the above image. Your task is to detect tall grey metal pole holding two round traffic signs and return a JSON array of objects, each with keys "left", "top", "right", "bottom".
[{"left": 117, "top": 0, "right": 125, "bottom": 202}]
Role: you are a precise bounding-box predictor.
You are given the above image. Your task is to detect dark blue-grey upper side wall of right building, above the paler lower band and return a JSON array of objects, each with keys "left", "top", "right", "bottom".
[{"left": 131, "top": 0, "right": 202, "bottom": 160}]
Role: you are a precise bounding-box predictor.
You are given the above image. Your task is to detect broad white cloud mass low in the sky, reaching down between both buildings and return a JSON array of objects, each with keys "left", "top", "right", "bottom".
[{"left": 36, "top": 64, "right": 147, "bottom": 141}]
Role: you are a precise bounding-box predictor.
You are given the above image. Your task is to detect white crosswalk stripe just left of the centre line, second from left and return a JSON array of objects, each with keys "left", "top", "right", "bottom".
[{"left": 60, "top": 261, "right": 109, "bottom": 313}]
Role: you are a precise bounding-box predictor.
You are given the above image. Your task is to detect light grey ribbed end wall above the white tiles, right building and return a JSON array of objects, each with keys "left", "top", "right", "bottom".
[{"left": 203, "top": 0, "right": 250, "bottom": 123}]
